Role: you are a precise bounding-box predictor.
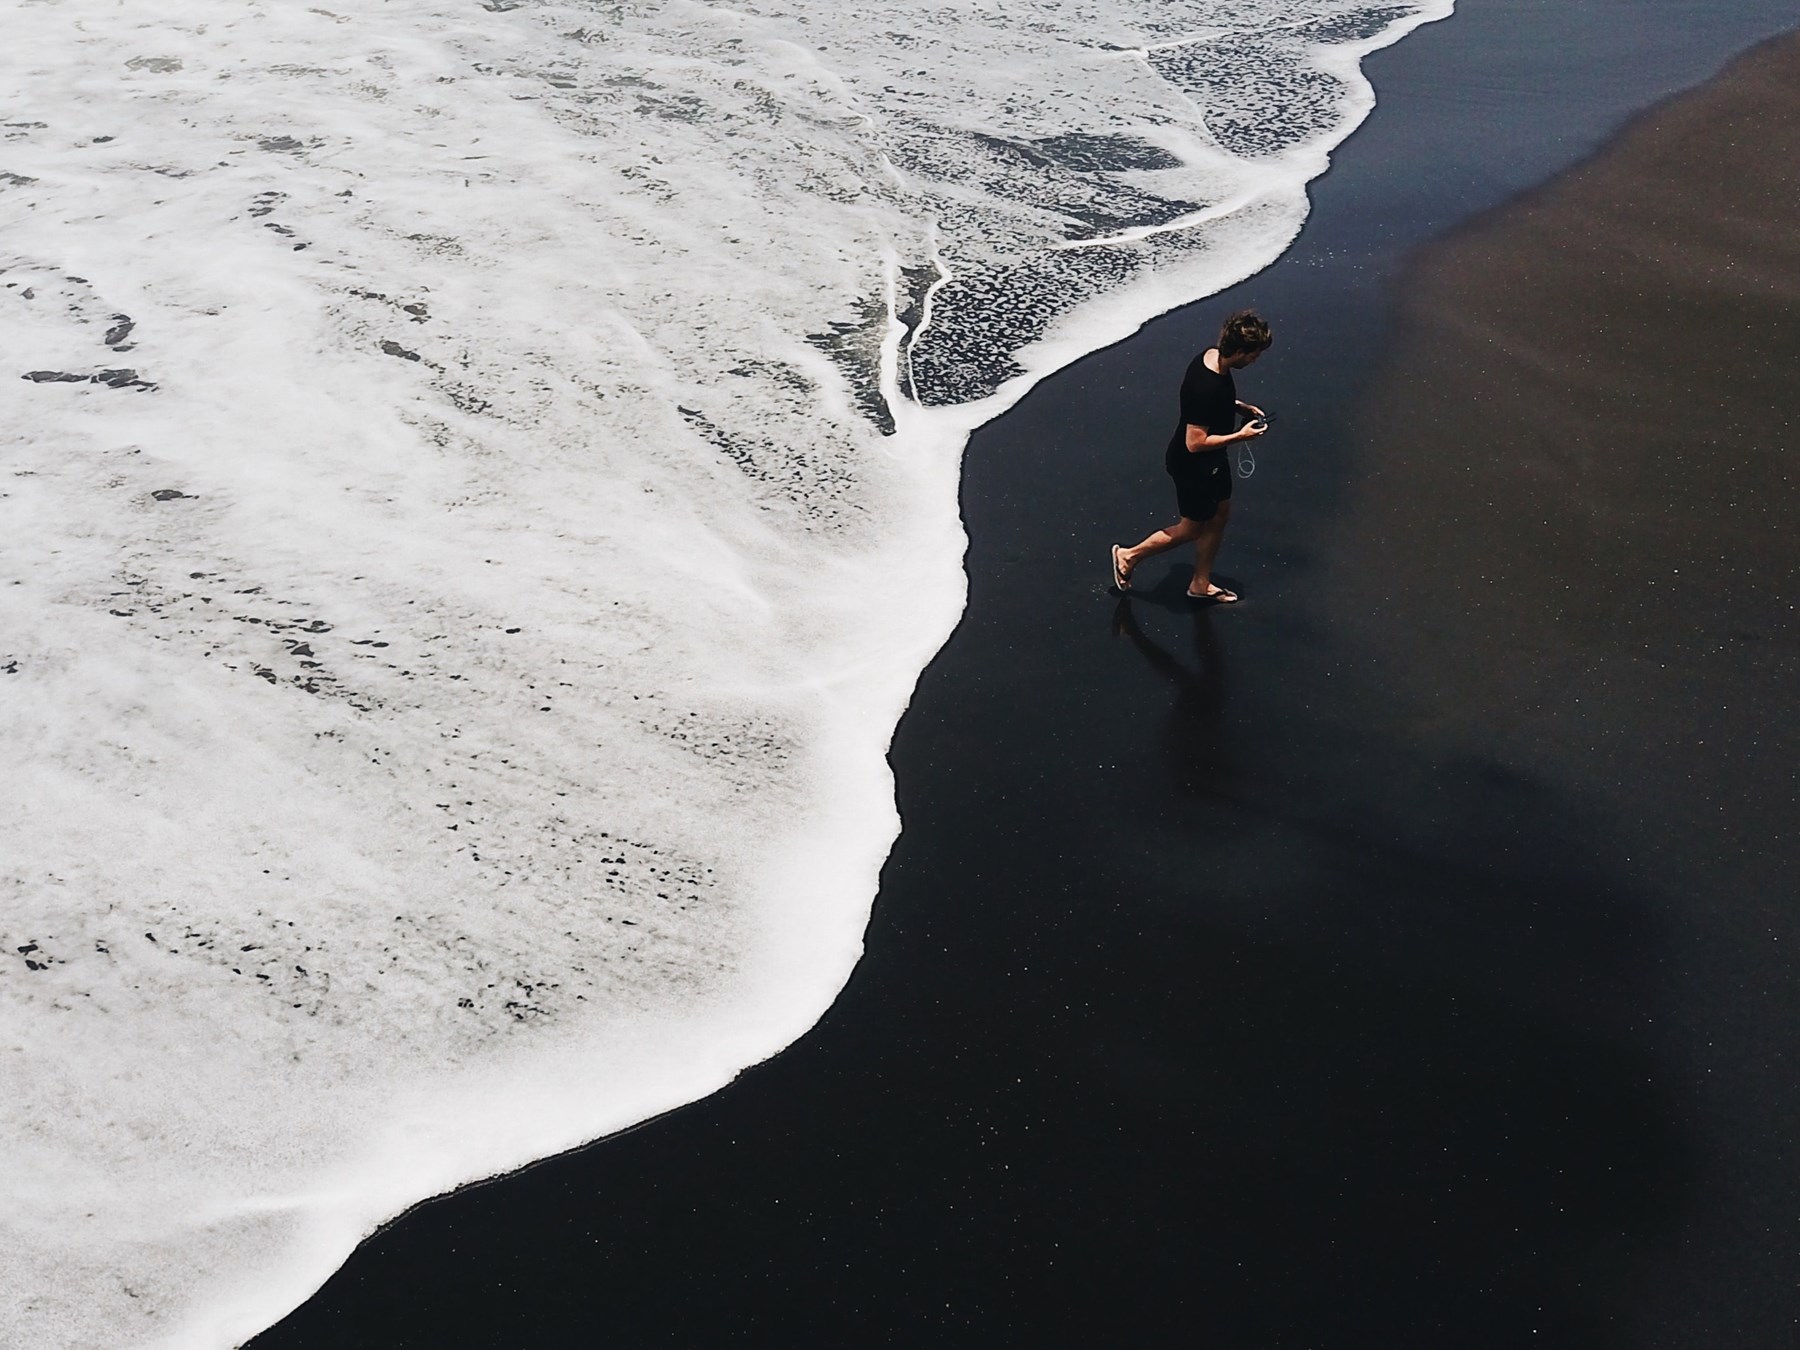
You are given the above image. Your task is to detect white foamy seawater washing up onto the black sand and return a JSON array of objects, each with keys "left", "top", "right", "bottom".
[{"left": 0, "top": 0, "right": 1449, "bottom": 1346}]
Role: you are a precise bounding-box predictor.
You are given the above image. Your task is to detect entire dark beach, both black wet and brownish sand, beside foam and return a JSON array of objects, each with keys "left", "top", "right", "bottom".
[{"left": 256, "top": 0, "right": 1800, "bottom": 1348}]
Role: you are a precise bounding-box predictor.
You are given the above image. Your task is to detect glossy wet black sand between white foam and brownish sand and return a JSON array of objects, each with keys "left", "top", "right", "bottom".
[{"left": 256, "top": 0, "right": 1800, "bottom": 1346}]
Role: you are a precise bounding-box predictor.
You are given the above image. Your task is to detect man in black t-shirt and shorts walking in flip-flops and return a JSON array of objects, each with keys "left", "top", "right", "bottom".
[{"left": 1112, "top": 310, "right": 1271, "bottom": 605}]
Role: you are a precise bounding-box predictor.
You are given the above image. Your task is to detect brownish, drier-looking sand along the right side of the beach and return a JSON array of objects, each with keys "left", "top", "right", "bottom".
[{"left": 1325, "top": 38, "right": 1800, "bottom": 1346}]
